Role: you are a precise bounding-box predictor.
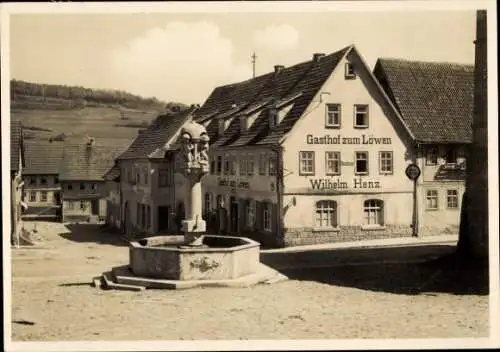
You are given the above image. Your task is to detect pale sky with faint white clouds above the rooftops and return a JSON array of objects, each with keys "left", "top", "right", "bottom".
[{"left": 10, "top": 10, "right": 475, "bottom": 104}]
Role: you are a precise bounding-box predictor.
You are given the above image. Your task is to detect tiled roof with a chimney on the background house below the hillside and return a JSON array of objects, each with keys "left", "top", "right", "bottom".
[{"left": 59, "top": 144, "right": 124, "bottom": 181}]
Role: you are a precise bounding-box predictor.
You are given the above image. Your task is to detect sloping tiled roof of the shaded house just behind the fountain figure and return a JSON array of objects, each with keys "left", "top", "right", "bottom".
[{"left": 117, "top": 107, "right": 196, "bottom": 160}]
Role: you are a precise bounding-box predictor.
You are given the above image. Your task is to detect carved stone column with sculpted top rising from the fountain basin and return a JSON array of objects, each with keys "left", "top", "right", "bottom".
[{"left": 181, "top": 122, "right": 209, "bottom": 246}]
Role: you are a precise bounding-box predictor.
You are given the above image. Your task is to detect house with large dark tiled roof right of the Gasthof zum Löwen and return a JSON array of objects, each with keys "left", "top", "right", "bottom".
[{"left": 374, "top": 59, "right": 474, "bottom": 234}]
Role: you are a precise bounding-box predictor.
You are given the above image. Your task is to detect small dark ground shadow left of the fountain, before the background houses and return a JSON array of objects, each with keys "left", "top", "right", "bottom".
[{"left": 59, "top": 223, "right": 128, "bottom": 247}]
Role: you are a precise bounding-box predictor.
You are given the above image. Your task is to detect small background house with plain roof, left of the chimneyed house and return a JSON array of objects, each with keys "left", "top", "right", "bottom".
[{"left": 23, "top": 140, "right": 64, "bottom": 219}]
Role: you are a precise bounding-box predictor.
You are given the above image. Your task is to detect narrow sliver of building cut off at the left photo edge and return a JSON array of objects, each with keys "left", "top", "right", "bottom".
[{"left": 10, "top": 120, "right": 25, "bottom": 243}]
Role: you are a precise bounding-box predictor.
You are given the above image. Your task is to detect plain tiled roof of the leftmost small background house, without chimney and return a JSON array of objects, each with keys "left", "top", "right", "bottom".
[{"left": 23, "top": 140, "right": 65, "bottom": 175}]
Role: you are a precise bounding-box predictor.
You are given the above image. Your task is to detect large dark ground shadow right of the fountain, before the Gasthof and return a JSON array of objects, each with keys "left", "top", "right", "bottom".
[{"left": 261, "top": 245, "right": 489, "bottom": 295}]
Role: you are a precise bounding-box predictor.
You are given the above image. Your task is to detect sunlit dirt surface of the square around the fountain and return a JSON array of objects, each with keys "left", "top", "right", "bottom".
[{"left": 11, "top": 222, "right": 489, "bottom": 341}]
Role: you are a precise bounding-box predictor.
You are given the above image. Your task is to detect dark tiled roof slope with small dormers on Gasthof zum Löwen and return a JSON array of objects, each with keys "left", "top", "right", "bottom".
[{"left": 195, "top": 46, "right": 351, "bottom": 147}]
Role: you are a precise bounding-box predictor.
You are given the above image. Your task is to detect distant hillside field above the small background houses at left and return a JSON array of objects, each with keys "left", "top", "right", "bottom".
[{"left": 11, "top": 99, "right": 159, "bottom": 145}]
